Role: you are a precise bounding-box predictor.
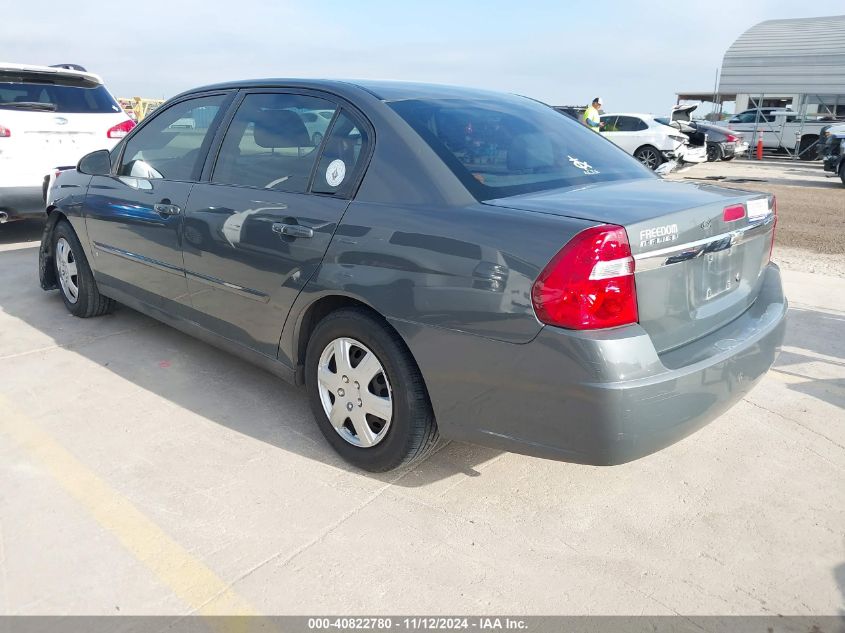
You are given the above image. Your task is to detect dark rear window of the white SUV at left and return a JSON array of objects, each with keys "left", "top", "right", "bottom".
[{"left": 0, "top": 83, "right": 120, "bottom": 113}]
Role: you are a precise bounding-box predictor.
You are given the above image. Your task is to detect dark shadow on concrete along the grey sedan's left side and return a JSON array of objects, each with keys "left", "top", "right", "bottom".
[{"left": 0, "top": 245, "right": 501, "bottom": 487}]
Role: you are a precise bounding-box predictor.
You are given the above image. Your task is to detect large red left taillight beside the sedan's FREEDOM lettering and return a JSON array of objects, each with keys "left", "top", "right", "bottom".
[{"left": 531, "top": 224, "right": 639, "bottom": 330}]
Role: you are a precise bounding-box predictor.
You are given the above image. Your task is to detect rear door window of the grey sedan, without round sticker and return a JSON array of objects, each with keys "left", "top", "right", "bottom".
[{"left": 211, "top": 93, "right": 335, "bottom": 193}]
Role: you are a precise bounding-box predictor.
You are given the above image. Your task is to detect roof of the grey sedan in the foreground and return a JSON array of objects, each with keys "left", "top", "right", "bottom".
[{"left": 185, "top": 78, "right": 532, "bottom": 101}]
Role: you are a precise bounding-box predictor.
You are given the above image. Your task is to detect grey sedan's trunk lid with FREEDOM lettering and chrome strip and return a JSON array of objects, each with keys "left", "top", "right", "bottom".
[{"left": 487, "top": 178, "right": 774, "bottom": 352}]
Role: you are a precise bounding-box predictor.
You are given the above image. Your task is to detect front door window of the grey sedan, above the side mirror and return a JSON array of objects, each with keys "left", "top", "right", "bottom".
[{"left": 118, "top": 95, "right": 226, "bottom": 180}]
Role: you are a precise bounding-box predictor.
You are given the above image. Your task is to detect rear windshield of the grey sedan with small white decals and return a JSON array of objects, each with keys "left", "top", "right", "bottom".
[{"left": 388, "top": 96, "right": 654, "bottom": 200}]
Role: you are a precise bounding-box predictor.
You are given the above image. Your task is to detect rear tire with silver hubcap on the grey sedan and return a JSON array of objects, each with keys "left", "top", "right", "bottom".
[{"left": 305, "top": 308, "right": 438, "bottom": 472}]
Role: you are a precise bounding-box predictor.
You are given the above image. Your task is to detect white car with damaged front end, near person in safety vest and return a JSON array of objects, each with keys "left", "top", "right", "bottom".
[{"left": 601, "top": 113, "right": 696, "bottom": 169}]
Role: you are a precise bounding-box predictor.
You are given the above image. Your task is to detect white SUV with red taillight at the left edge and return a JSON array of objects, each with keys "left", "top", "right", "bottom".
[{"left": 0, "top": 62, "right": 135, "bottom": 223}]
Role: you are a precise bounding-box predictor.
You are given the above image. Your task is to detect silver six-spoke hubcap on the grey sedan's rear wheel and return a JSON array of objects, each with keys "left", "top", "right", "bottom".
[{"left": 317, "top": 337, "right": 393, "bottom": 448}]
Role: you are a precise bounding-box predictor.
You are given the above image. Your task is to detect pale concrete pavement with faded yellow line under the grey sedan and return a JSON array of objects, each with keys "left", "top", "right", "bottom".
[{"left": 0, "top": 227, "right": 845, "bottom": 615}]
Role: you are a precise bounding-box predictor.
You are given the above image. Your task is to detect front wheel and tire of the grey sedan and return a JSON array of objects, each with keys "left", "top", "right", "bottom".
[{"left": 53, "top": 220, "right": 115, "bottom": 319}]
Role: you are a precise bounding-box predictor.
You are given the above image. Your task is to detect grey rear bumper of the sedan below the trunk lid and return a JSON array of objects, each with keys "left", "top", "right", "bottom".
[{"left": 397, "top": 265, "right": 787, "bottom": 465}]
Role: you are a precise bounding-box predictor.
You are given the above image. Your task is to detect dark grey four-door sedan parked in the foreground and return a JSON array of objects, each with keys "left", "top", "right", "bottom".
[{"left": 39, "top": 80, "right": 787, "bottom": 471}]
